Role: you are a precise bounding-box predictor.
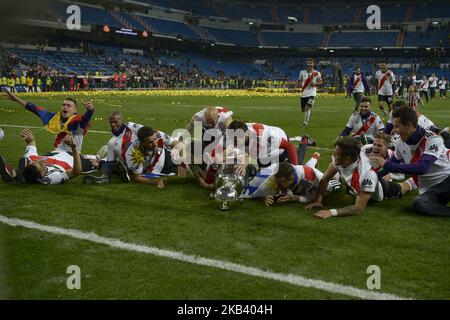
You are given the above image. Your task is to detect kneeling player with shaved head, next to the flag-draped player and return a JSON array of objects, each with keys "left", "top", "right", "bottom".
[{"left": 83, "top": 111, "right": 143, "bottom": 184}]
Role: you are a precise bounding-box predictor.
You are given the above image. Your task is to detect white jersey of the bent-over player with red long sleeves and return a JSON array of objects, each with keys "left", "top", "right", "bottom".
[{"left": 247, "top": 123, "right": 288, "bottom": 164}]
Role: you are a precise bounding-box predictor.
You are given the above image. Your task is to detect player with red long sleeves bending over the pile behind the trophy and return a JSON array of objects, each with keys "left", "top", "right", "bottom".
[{"left": 226, "top": 120, "right": 298, "bottom": 176}]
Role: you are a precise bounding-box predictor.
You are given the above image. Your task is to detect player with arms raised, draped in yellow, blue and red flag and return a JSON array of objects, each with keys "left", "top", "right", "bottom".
[{"left": 4, "top": 90, "right": 94, "bottom": 152}]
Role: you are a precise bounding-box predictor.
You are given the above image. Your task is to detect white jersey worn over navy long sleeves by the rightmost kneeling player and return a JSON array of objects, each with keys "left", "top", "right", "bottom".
[{"left": 395, "top": 131, "right": 450, "bottom": 194}]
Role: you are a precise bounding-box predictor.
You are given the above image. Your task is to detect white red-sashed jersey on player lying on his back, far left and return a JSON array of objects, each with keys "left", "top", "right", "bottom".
[{"left": 24, "top": 146, "right": 73, "bottom": 184}]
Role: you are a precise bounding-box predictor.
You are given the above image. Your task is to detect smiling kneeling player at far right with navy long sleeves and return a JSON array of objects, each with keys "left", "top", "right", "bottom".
[{"left": 371, "top": 107, "right": 450, "bottom": 217}]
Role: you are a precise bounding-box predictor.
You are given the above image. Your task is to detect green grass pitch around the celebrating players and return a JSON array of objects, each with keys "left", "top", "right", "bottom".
[{"left": 0, "top": 92, "right": 450, "bottom": 299}]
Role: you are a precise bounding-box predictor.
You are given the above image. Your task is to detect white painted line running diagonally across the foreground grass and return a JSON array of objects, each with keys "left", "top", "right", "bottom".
[{"left": 0, "top": 215, "right": 410, "bottom": 300}]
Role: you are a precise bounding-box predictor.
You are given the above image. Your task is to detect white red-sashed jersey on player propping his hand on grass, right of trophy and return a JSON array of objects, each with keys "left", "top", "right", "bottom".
[{"left": 333, "top": 152, "right": 383, "bottom": 201}]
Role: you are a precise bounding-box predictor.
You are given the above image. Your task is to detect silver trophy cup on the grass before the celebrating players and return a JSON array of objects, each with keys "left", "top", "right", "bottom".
[{"left": 213, "top": 164, "right": 248, "bottom": 211}]
